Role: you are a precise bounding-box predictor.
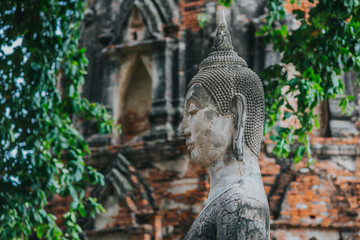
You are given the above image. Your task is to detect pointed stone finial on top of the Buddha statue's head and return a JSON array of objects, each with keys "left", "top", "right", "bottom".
[{"left": 212, "top": 11, "right": 234, "bottom": 51}]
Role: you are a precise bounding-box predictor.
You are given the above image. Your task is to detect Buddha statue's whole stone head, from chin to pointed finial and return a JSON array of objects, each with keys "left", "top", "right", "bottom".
[{"left": 180, "top": 14, "right": 264, "bottom": 167}]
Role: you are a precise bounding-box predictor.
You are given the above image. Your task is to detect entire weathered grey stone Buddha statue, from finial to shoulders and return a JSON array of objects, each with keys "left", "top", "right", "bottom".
[{"left": 180, "top": 13, "right": 270, "bottom": 240}]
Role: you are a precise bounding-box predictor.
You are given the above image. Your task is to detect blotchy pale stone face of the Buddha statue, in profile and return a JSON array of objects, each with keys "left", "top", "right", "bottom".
[{"left": 180, "top": 83, "right": 234, "bottom": 167}]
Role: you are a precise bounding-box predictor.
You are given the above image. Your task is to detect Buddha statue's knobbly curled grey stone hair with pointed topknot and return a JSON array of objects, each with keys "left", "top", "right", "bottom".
[{"left": 188, "top": 12, "right": 265, "bottom": 156}]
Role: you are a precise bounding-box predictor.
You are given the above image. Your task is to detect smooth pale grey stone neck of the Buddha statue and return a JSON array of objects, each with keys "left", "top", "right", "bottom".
[{"left": 207, "top": 145, "right": 261, "bottom": 202}]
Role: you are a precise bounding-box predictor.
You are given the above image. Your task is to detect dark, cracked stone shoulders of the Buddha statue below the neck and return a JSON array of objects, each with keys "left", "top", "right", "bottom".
[{"left": 185, "top": 183, "right": 270, "bottom": 240}]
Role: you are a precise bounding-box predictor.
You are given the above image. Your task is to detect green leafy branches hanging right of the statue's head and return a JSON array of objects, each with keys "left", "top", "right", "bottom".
[{"left": 257, "top": 0, "right": 360, "bottom": 162}]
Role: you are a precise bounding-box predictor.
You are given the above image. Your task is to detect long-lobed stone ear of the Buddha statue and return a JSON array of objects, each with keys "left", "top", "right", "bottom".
[{"left": 231, "top": 93, "right": 246, "bottom": 161}]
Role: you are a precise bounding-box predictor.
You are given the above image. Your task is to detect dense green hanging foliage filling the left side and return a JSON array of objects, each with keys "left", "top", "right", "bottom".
[{"left": 0, "top": 0, "right": 111, "bottom": 239}]
